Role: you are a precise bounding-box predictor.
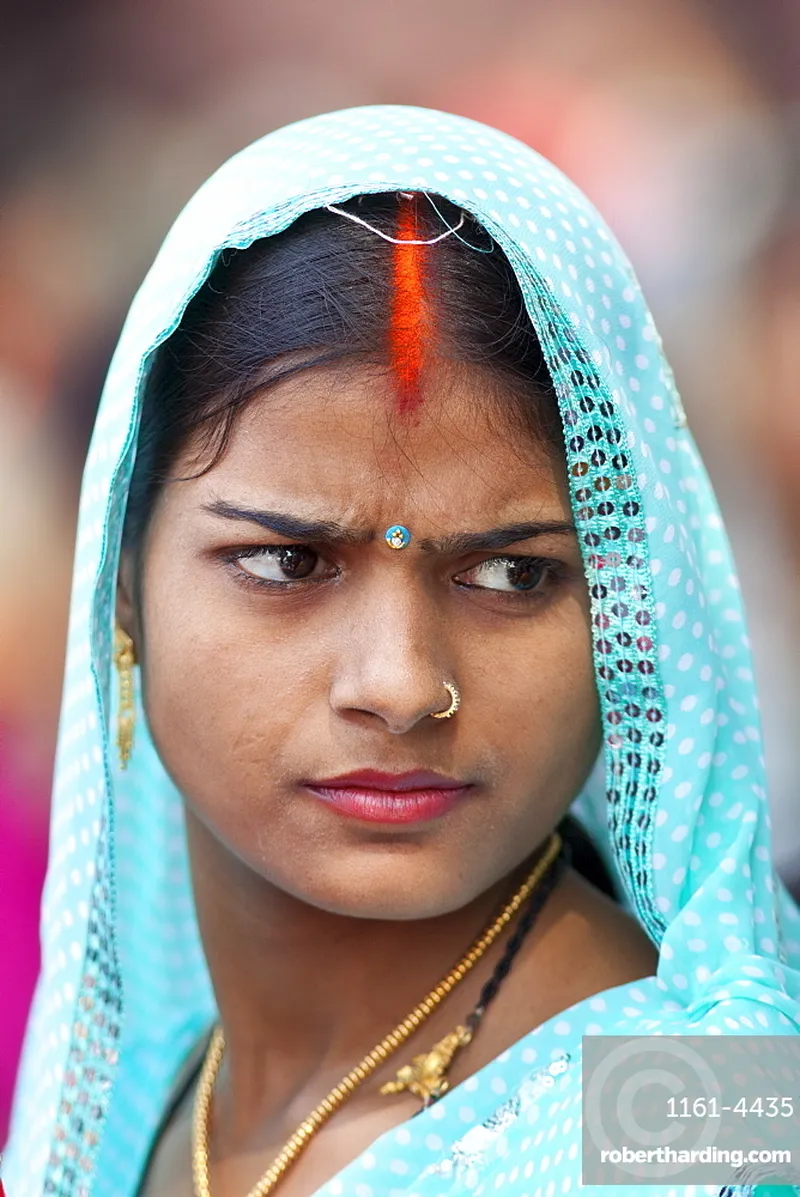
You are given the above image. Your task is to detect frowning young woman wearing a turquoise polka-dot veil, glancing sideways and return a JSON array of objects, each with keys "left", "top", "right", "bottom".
[{"left": 5, "top": 108, "right": 800, "bottom": 1197}]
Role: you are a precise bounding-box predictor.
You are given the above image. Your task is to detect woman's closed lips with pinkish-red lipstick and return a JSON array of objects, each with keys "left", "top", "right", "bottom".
[{"left": 303, "top": 768, "right": 474, "bottom": 824}]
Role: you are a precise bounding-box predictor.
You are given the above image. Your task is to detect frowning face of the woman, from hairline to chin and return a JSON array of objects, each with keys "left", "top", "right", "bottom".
[{"left": 120, "top": 365, "right": 600, "bottom": 918}]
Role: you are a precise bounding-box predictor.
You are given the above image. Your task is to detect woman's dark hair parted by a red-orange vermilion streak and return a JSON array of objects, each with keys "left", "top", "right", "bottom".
[{"left": 125, "top": 193, "right": 563, "bottom": 546}]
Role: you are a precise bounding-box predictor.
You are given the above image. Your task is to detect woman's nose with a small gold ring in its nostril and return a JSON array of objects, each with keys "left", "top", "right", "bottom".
[{"left": 331, "top": 574, "right": 454, "bottom": 735}]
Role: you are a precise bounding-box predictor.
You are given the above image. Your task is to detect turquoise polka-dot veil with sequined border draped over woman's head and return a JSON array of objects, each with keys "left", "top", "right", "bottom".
[{"left": 4, "top": 107, "right": 800, "bottom": 1197}]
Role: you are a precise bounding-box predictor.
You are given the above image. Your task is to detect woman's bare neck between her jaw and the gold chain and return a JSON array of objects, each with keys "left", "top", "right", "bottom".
[{"left": 187, "top": 814, "right": 526, "bottom": 1116}]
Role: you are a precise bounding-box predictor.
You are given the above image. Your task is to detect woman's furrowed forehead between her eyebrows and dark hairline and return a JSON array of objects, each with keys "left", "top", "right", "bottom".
[{"left": 177, "top": 363, "right": 569, "bottom": 518}]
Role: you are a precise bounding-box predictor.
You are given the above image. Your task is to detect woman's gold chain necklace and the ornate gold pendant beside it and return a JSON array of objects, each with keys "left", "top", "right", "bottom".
[{"left": 192, "top": 832, "right": 562, "bottom": 1197}]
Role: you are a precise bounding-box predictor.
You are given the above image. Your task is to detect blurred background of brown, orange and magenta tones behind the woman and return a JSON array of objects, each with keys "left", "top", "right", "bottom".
[{"left": 0, "top": 0, "right": 800, "bottom": 1143}]
